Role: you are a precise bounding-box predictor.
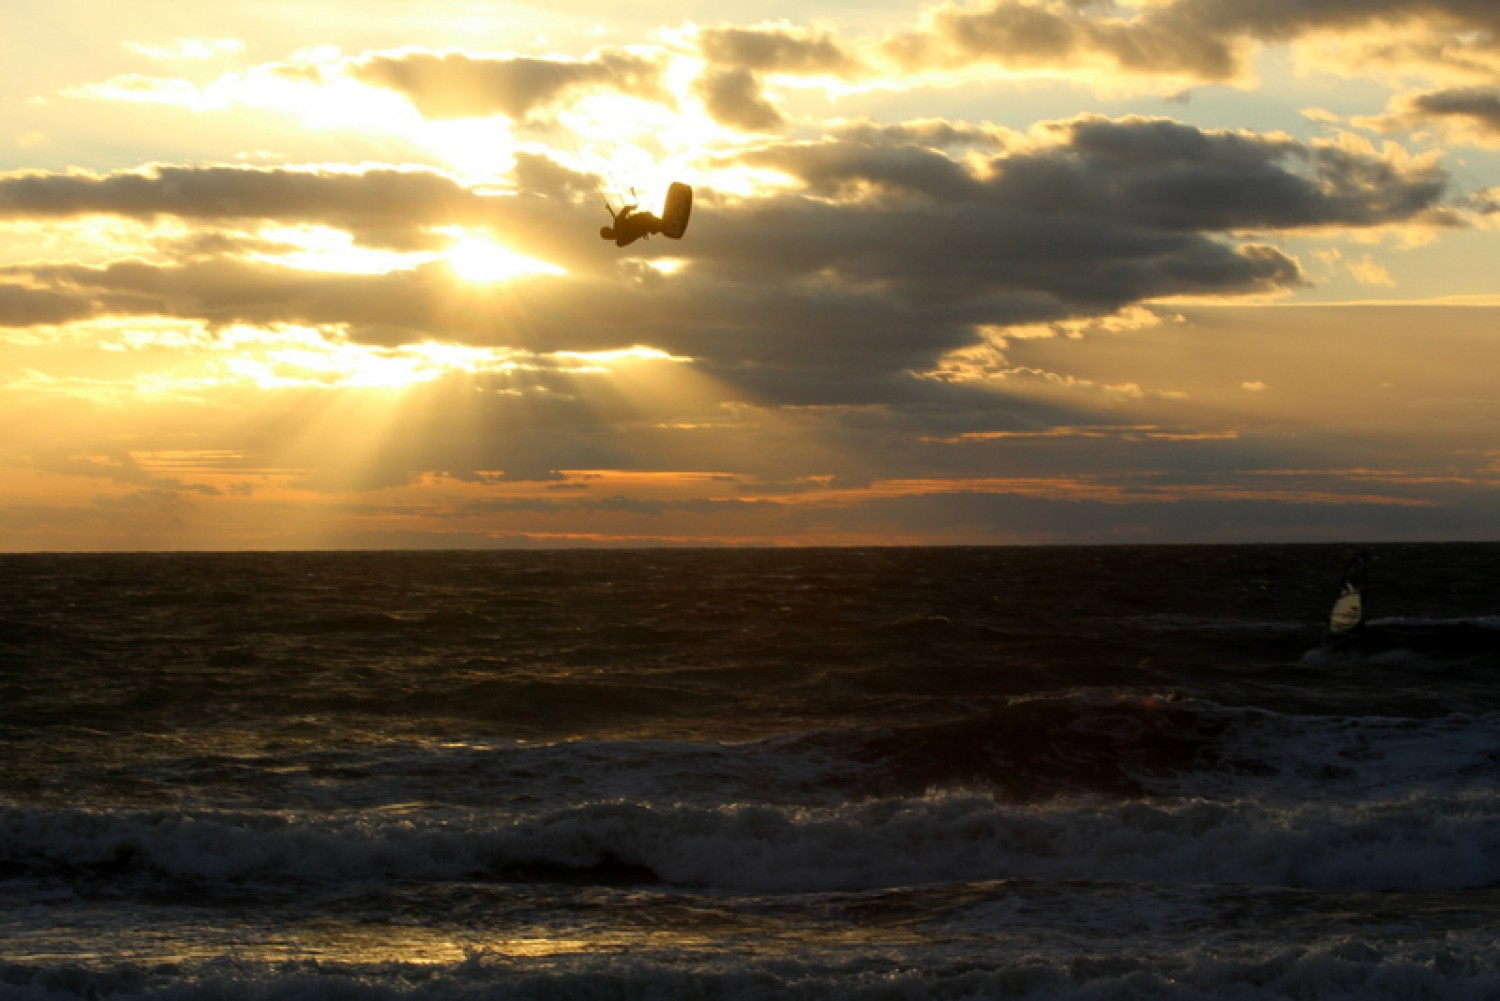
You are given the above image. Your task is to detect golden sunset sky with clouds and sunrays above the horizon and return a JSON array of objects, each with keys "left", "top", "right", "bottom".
[{"left": 0, "top": 0, "right": 1500, "bottom": 551}]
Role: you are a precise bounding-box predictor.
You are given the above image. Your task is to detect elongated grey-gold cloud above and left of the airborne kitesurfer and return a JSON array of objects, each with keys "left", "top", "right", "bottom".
[{"left": 351, "top": 53, "right": 668, "bottom": 120}]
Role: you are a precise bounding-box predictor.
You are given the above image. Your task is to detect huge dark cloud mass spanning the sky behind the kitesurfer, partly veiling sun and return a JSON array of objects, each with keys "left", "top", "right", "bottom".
[{"left": 0, "top": 119, "right": 1449, "bottom": 402}]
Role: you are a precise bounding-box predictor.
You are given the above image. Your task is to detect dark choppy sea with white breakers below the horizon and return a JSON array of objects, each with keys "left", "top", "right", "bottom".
[{"left": 0, "top": 543, "right": 1500, "bottom": 1001}]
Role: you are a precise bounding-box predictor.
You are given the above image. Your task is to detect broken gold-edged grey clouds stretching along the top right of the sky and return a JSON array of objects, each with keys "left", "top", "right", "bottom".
[{"left": 702, "top": 0, "right": 1500, "bottom": 129}]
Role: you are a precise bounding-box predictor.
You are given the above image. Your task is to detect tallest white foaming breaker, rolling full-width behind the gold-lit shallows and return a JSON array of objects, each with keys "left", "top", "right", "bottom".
[{"left": 11, "top": 791, "right": 1500, "bottom": 893}]
